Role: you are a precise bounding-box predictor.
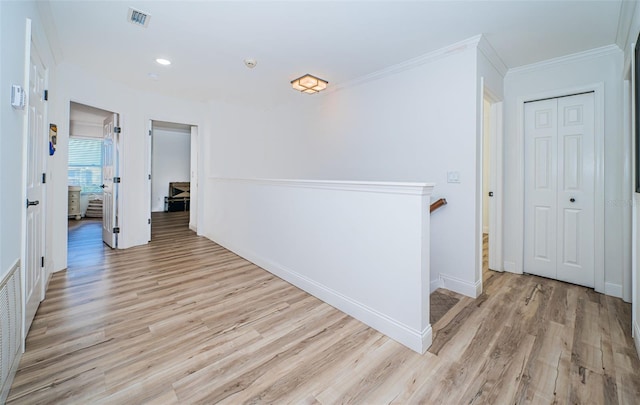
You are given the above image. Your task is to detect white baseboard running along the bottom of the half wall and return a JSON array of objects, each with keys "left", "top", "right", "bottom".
[{"left": 206, "top": 235, "right": 433, "bottom": 354}]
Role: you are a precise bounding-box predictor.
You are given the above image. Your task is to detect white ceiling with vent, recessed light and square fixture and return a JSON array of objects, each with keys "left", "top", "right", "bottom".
[{"left": 39, "top": 0, "right": 628, "bottom": 103}]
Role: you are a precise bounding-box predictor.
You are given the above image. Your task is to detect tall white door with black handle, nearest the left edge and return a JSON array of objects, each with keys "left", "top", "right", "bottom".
[{"left": 23, "top": 42, "right": 48, "bottom": 337}]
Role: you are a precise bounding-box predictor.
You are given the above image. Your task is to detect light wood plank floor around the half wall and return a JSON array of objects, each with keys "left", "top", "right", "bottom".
[{"left": 9, "top": 213, "right": 640, "bottom": 404}]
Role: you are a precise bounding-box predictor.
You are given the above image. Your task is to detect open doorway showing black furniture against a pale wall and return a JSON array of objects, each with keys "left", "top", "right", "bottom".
[{"left": 149, "top": 120, "right": 197, "bottom": 241}]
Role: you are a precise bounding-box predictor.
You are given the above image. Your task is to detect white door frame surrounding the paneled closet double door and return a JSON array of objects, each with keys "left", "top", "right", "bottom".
[{"left": 512, "top": 82, "right": 605, "bottom": 293}]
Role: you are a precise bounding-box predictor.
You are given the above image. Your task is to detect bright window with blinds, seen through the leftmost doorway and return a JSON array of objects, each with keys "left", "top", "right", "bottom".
[{"left": 69, "top": 138, "right": 102, "bottom": 193}]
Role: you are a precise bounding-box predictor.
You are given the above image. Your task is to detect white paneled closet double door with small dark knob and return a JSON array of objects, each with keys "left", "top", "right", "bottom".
[{"left": 524, "top": 92, "right": 595, "bottom": 287}]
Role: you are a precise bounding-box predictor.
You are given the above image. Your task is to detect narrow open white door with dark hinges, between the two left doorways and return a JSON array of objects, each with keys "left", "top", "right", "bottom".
[{"left": 102, "top": 114, "right": 120, "bottom": 249}]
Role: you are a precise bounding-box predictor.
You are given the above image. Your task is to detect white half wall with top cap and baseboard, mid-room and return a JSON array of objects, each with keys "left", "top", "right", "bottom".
[{"left": 205, "top": 178, "right": 432, "bottom": 353}]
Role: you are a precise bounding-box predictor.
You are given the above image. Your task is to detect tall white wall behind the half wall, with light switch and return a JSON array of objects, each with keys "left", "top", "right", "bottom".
[{"left": 204, "top": 39, "right": 481, "bottom": 296}]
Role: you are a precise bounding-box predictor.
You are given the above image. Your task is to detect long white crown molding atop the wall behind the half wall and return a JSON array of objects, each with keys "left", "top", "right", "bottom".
[{"left": 322, "top": 35, "right": 482, "bottom": 94}]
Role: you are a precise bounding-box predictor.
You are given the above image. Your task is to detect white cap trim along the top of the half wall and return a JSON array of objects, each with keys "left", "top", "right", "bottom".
[{"left": 209, "top": 177, "right": 435, "bottom": 195}]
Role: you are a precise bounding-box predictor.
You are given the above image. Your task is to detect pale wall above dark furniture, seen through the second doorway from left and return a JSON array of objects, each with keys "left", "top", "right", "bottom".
[{"left": 151, "top": 126, "right": 191, "bottom": 212}]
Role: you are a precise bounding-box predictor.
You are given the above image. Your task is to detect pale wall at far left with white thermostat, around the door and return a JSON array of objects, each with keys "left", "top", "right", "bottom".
[{"left": 0, "top": 1, "right": 57, "bottom": 279}]
